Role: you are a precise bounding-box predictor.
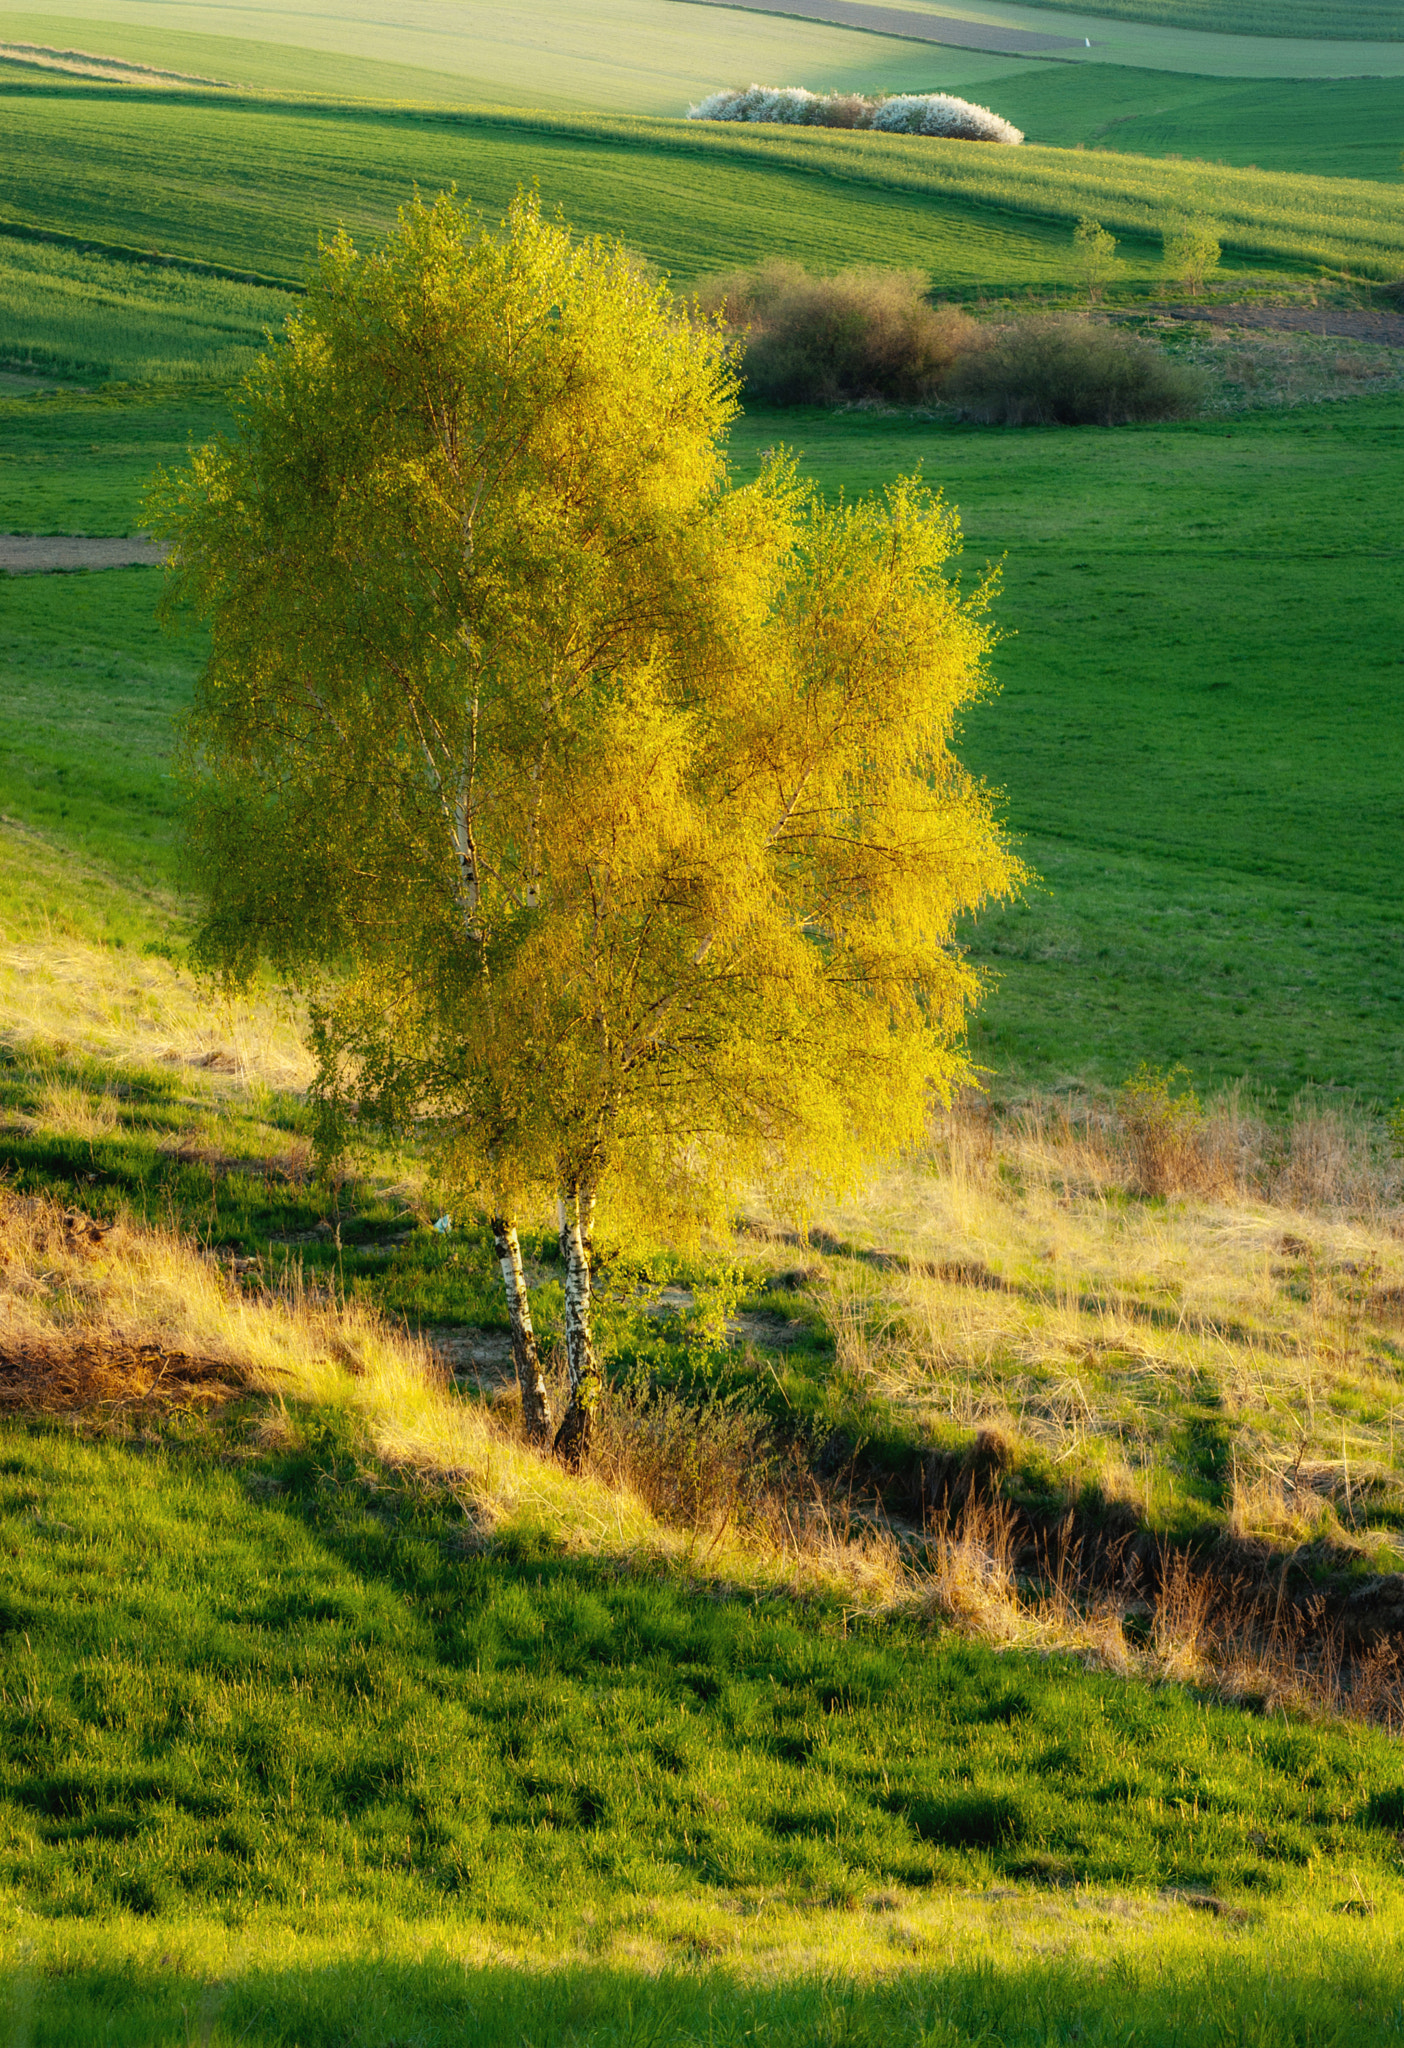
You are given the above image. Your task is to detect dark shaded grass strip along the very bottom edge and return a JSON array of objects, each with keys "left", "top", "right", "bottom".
[{"left": 11, "top": 1929, "right": 1404, "bottom": 2048}]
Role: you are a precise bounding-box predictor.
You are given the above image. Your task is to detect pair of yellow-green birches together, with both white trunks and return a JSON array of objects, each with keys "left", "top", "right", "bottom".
[{"left": 153, "top": 199, "right": 1019, "bottom": 1460}]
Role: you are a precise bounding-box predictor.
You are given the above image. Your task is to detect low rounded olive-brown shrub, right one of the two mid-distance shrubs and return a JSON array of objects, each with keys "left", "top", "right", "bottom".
[{"left": 946, "top": 315, "right": 1203, "bottom": 426}]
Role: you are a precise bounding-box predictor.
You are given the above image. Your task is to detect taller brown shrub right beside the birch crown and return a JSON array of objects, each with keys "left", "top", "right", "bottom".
[{"left": 698, "top": 258, "right": 980, "bottom": 406}]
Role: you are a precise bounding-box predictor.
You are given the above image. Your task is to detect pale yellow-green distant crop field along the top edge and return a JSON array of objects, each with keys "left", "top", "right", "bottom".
[{"left": 11, "top": 0, "right": 1404, "bottom": 92}]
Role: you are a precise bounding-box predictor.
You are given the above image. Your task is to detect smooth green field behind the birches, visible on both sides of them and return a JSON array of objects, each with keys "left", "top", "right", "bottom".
[{"left": 0, "top": 378, "right": 1404, "bottom": 1102}]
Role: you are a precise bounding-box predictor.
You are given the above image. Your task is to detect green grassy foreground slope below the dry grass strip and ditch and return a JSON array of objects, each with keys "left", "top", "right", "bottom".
[{"left": 0, "top": 1415, "right": 1400, "bottom": 2048}]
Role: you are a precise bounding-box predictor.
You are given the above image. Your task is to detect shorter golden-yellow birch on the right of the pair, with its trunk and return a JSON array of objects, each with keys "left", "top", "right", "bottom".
[{"left": 511, "top": 467, "right": 1021, "bottom": 1456}]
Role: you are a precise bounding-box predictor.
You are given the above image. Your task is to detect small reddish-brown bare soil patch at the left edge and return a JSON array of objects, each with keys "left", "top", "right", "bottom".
[{"left": 0, "top": 1337, "right": 239, "bottom": 1415}]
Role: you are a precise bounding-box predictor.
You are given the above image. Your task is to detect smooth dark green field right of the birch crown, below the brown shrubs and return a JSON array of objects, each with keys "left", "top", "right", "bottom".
[{"left": 735, "top": 397, "right": 1404, "bottom": 1100}]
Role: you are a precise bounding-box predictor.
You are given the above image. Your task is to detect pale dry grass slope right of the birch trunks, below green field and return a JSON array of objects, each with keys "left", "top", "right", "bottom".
[{"left": 785, "top": 1106, "right": 1404, "bottom": 1540}]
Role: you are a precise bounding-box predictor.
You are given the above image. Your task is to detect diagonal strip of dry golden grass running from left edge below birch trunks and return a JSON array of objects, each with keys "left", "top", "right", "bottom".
[{"left": 0, "top": 1194, "right": 907, "bottom": 1606}]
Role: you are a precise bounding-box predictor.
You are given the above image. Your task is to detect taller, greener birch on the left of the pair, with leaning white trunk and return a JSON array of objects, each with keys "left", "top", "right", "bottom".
[{"left": 151, "top": 197, "right": 757, "bottom": 1436}]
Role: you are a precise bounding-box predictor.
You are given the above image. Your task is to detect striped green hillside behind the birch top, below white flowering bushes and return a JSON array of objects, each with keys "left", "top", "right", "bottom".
[{"left": 0, "top": 86, "right": 1404, "bottom": 367}]
